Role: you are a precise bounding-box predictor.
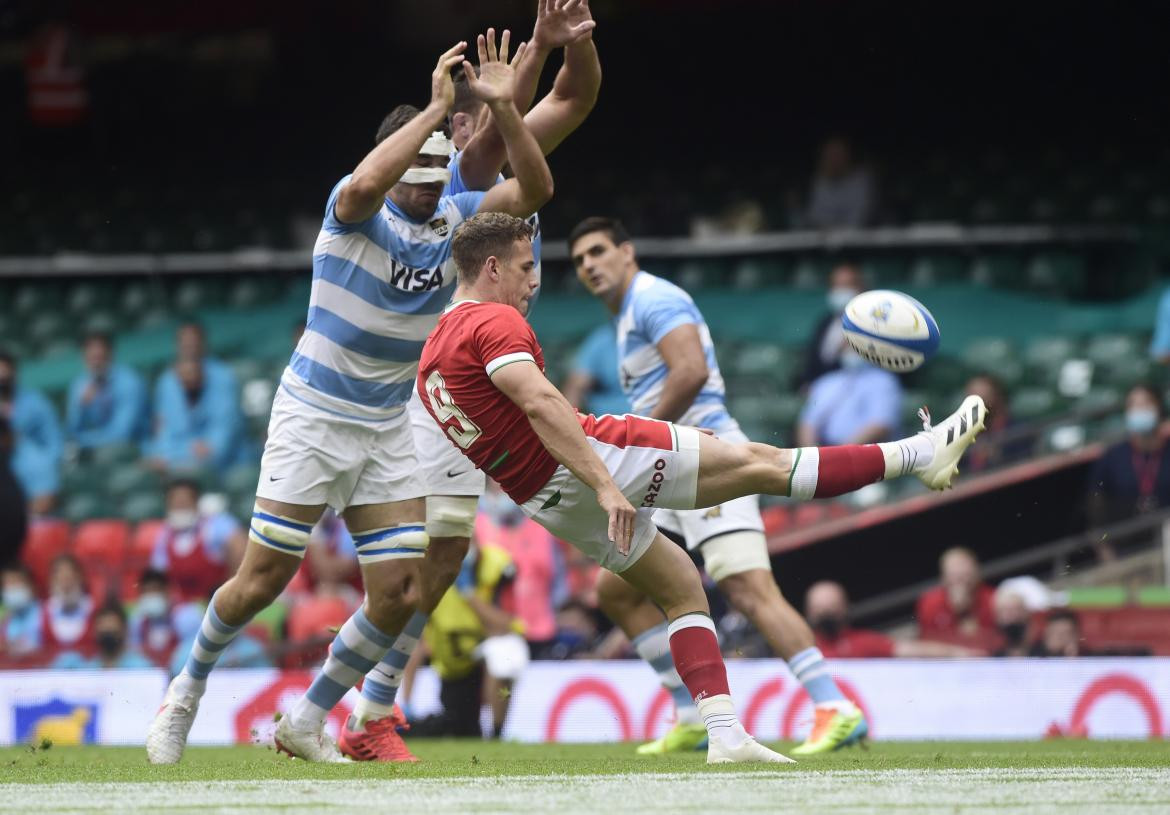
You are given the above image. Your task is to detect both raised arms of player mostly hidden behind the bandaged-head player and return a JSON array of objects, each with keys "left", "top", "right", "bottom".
[{"left": 460, "top": 0, "right": 601, "bottom": 184}]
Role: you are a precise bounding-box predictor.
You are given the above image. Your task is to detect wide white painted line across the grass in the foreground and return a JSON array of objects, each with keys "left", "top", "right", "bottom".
[{"left": 0, "top": 767, "right": 1170, "bottom": 815}]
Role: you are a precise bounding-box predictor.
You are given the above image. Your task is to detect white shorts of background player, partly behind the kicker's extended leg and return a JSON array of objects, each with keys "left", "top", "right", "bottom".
[{"left": 654, "top": 428, "right": 771, "bottom": 580}]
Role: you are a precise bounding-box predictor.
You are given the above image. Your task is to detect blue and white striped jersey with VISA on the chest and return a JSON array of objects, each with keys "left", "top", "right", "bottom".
[{"left": 281, "top": 175, "right": 483, "bottom": 421}]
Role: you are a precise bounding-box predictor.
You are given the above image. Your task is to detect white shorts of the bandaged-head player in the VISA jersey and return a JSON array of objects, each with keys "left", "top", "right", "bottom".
[{"left": 256, "top": 387, "right": 426, "bottom": 512}]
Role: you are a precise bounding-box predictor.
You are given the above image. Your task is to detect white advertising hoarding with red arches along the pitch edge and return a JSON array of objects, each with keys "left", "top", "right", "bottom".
[{"left": 0, "top": 658, "right": 1170, "bottom": 745}]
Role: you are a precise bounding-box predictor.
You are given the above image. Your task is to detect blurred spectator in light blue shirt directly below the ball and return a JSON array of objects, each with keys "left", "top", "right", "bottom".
[{"left": 797, "top": 348, "right": 902, "bottom": 447}]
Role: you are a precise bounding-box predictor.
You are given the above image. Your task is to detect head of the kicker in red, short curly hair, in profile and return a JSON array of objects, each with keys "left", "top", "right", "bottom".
[{"left": 450, "top": 213, "right": 541, "bottom": 315}]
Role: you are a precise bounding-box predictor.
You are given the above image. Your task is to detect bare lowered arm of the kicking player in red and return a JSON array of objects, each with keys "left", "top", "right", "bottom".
[{"left": 491, "top": 360, "right": 635, "bottom": 554}]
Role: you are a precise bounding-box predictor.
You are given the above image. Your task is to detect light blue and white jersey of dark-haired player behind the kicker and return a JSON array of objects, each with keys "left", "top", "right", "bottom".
[{"left": 618, "top": 271, "right": 738, "bottom": 430}]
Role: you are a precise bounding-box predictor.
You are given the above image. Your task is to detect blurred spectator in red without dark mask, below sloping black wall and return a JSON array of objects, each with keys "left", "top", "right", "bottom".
[{"left": 915, "top": 546, "right": 996, "bottom": 644}]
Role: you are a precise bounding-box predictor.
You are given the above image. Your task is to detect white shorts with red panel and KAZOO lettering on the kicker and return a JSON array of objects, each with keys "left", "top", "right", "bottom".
[{"left": 523, "top": 416, "right": 698, "bottom": 573}]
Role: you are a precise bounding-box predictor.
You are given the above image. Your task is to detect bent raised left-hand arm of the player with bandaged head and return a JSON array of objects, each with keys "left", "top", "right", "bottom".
[{"left": 335, "top": 42, "right": 467, "bottom": 223}]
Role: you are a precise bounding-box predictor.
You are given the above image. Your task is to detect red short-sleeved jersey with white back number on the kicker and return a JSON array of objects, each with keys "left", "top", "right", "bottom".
[{"left": 417, "top": 301, "right": 557, "bottom": 504}]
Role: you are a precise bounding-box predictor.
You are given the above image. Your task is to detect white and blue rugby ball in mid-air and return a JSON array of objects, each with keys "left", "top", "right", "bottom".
[{"left": 841, "top": 289, "right": 938, "bottom": 373}]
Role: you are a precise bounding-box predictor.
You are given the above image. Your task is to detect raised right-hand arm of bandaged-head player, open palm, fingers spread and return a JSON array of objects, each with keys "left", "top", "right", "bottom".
[{"left": 463, "top": 32, "right": 552, "bottom": 217}]
